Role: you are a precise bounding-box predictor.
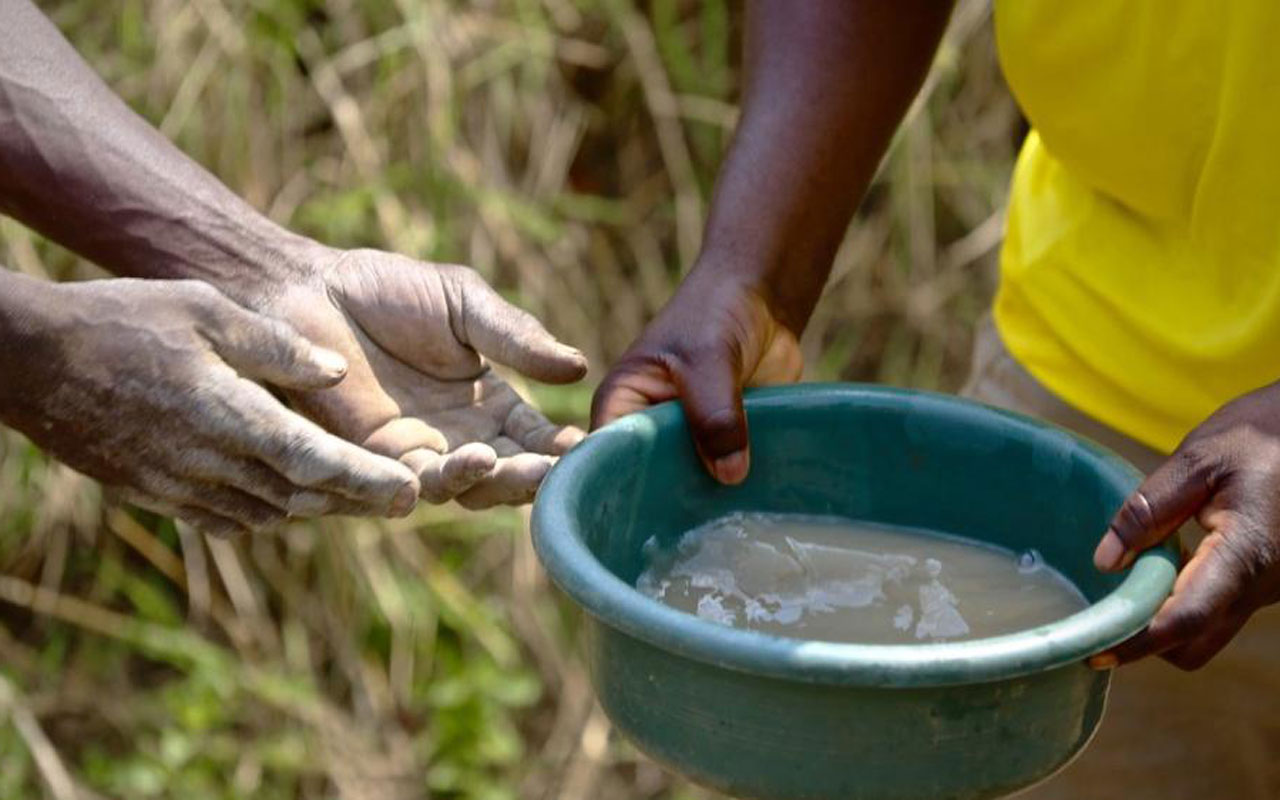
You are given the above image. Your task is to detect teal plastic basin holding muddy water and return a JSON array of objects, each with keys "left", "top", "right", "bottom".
[{"left": 532, "top": 385, "right": 1176, "bottom": 800}]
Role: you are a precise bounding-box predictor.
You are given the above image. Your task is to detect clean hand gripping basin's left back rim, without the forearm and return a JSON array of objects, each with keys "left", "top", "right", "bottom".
[{"left": 591, "top": 271, "right": 804, "bottom": 484}]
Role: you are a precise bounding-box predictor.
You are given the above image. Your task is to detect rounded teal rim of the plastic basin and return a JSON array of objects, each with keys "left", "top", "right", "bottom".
[{"left": 531, "top": 384, "right": 1176, "bottom": 687}]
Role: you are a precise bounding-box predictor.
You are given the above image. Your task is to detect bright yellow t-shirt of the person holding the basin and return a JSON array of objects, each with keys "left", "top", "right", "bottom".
[{"left": 995, "top": 0, "right": 1280, "bottom": 452}]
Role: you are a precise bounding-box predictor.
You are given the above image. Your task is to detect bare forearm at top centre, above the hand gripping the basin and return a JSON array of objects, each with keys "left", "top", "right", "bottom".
[{"left": 698, "top": 0, "right": 951, "bottom": 333}]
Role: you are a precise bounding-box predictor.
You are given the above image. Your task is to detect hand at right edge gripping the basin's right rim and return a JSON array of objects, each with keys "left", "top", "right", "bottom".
[{"left": 1092, "top": 384, "right": 1280, "bottom": 669}]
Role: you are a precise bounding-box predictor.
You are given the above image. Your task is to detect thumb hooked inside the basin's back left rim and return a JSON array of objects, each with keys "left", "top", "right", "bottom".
[{"left": 673, "top": 345, "right": 750, "bottom": 485}]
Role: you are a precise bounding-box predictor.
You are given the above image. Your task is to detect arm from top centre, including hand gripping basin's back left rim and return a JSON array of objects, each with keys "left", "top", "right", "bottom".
[{"left": 591, "top": 0, "right": 951, "bottom": 484}]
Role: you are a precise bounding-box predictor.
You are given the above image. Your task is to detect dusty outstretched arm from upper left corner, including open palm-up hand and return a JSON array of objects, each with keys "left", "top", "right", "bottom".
[{"left": 0, "top": 0, "right": 586, "bottom": 508}]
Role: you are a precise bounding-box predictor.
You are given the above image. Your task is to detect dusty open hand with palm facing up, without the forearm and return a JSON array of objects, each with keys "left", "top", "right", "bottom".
[{"left": 260, "top": 250, "right": 586, "bottom": 508}]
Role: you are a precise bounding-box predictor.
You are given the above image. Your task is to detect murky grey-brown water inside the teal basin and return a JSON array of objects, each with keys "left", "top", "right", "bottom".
[{"left": 636, "top": 513, "right": 1087, "bottom": 644}]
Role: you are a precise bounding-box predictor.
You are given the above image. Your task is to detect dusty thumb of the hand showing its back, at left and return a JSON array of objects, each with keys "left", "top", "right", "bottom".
[{"left": 202, "top": 300, "right": 347, "bottom": 389}]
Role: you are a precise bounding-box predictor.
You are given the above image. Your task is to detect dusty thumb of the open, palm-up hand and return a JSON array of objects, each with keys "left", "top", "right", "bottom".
[{"left": 454, "top": 270, "right": 586, "bottom": 383}]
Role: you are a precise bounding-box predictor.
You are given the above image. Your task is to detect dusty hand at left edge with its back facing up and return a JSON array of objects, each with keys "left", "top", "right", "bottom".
[{"left": 0, "top": 280, "right": 417, "bottom": 535}]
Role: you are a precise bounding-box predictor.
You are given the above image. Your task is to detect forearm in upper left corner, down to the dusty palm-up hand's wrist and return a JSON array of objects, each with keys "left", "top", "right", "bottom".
[{"left": 0, "top": 0, "right": 307, "bottom": 293}]
